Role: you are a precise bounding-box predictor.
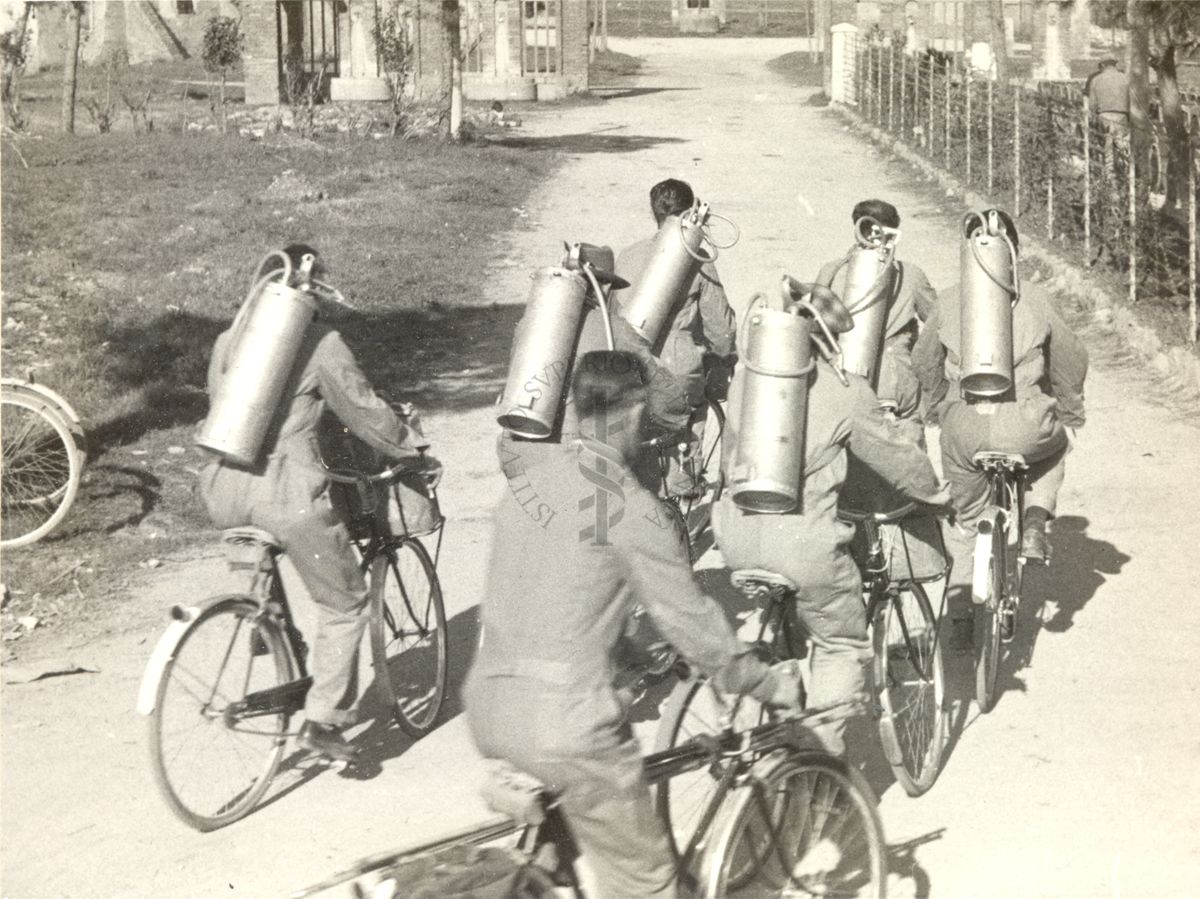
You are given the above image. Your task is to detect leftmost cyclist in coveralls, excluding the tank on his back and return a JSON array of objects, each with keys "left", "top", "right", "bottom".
[{"left": 199, "top": 244, "right": 440, "bottom": 761}]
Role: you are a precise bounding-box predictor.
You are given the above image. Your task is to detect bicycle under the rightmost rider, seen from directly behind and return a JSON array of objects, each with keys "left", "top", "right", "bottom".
[{"left": 971, "top": 453, "right": 1028, "bottom": 713}]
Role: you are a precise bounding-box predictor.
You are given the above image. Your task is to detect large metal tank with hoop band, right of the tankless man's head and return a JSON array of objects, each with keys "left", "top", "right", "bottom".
[{"left": 730, "top": 276, "right": 851, "bottom": 514}]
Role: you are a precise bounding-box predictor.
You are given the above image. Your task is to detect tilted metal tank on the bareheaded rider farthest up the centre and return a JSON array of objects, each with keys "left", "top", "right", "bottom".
[{"left": 619, "top": 200, "right": 737, "bottom": 347}]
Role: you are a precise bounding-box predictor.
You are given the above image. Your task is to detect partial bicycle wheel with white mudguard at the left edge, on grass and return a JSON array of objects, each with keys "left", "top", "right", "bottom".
[{"left": 0, "top": 388, "right": 84, "bottom": 549}]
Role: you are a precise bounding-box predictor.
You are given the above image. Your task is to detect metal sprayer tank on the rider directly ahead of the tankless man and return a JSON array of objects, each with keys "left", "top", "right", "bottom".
[{"left": 496, "top": 238, "right": 628, "bottom": 439}]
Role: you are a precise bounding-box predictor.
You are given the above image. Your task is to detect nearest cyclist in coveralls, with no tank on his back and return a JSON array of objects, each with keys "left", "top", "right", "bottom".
[{"left": 463, "top": 350, "right": 799, "bottom": 899}]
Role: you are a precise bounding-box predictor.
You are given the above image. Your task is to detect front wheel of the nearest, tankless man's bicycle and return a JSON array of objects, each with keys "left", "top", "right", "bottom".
[{"left": 701, "top": 751, "right": 887, "bottom": 899}]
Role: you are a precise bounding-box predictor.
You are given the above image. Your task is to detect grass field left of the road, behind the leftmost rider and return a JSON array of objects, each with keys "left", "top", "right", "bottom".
[{"left": 0, "top": 117, "right": 556, "bottom": 634}]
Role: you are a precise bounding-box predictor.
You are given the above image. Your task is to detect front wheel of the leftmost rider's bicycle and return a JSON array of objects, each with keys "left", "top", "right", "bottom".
[{"left": 371, "top": 538, "right": 448, "bottom": 737}]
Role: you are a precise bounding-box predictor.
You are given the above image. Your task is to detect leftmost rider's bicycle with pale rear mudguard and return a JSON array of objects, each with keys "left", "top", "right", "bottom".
[{"left": 138, "top": 456, "right": 446, "bottom": 831}]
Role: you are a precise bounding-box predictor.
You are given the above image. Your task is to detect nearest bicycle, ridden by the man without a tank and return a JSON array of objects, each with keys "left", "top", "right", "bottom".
[{"left": 293, "top": 699, "right": 887, "bottom": 899}]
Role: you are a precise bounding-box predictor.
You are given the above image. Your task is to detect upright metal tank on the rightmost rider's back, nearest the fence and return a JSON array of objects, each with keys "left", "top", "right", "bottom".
[{"left": 959, "top": 209, "right": 1020, "bottom": 397}]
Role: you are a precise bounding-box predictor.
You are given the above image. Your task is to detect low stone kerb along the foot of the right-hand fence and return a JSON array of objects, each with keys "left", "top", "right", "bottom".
[{"left": 829, "top": 103, "right": 1200, "bottom": 400}]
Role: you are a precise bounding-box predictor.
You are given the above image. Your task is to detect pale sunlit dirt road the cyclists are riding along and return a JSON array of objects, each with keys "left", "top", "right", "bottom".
[{"left": 0, "top": 40, "right": 1200, "bottom": 899}]
